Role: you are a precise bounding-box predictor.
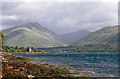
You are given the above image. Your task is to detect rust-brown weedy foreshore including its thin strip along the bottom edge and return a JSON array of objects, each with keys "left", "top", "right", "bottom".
[{"left": 2, "top": 53, "right": 115, "bottom": 79}]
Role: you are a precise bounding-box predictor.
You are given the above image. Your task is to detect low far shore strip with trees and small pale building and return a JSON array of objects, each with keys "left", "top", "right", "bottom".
[{"left": 2, "top": 46, "right": 118, "bottom": 53}]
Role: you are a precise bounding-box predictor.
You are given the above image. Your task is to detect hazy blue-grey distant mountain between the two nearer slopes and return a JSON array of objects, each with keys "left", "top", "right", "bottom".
[{"left": 60, "top": 30, "right": 90, "bottom": 44}]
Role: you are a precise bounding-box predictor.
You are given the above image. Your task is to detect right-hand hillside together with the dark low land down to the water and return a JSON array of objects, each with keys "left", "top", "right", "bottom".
[{"left": 44, "top": 26, "right": 120, "bottom": 53}]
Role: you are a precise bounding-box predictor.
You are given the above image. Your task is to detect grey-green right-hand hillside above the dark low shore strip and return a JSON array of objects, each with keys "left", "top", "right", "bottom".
[{"left": 72, "top": 26, "right": 118, "bottom": 47}]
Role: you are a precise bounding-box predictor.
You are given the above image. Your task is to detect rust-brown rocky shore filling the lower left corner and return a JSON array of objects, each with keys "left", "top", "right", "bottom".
[{"left": 2, "top": 53, "right": 69, "bottom": 78}]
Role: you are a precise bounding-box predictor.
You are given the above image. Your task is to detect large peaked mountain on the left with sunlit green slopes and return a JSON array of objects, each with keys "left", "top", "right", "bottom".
[{"left": 3, "top": 22, "right": 65, "bottom": 48}]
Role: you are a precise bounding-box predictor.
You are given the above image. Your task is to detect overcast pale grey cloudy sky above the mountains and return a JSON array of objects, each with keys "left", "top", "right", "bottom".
[{"left": 0, "top": 1, "right": 118, "bottom": 34}]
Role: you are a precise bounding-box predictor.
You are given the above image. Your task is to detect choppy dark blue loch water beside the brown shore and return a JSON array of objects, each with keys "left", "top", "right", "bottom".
[{"left": 11, "top": 53, "right": 119, "bottom": 77}]
